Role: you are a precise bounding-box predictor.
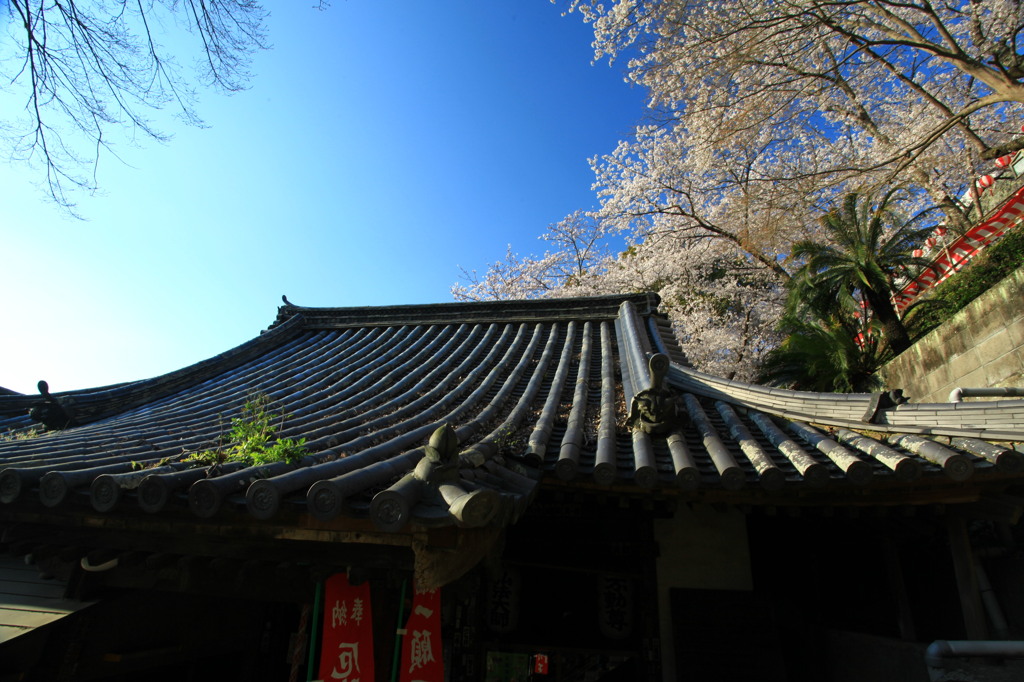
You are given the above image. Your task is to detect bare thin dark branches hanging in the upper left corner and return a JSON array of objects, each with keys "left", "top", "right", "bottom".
[{"left": 0, "top": 0, "right": 265, "bottom": 209}]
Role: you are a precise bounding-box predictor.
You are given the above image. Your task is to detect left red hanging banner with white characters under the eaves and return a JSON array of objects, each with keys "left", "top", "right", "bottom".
[{"left": 319, "top": 573, "right": 374, "bottom": 682}]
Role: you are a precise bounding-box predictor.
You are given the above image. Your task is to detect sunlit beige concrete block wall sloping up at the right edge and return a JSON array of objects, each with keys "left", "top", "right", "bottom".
[{"left": 881, "top": 268, "right": 1024, "bottom": 402}]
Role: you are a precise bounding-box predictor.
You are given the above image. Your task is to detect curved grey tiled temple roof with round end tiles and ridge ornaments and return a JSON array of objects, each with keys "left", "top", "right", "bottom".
[{"left": 0, "top": 295, "right": 1024, "bottom": 530}]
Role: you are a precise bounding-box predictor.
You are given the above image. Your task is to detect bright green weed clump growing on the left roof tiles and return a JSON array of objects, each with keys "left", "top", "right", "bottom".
[{"left": 184, "top": 393, "right": 307, "bottom": 466}]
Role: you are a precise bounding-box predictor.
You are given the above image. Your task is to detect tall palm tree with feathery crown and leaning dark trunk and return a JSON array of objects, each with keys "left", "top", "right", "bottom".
[{"left": 790, "top": 188, "right": 933, "bottom": 354}]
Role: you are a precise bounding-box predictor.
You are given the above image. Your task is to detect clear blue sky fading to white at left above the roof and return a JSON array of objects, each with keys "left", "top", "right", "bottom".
[{"left": 0, "top": 0, "right": 644, "bottom": 392}]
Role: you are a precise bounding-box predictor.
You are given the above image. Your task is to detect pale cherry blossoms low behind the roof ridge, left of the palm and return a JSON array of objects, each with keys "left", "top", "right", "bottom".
[{"left": 452, "top": 213, "right": 784, "bottom": 379}]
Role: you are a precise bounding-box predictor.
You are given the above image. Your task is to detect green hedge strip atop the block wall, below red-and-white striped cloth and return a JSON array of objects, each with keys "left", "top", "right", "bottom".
[{"left": 908, "top": 227, "right": 1024, "bottom": 338}]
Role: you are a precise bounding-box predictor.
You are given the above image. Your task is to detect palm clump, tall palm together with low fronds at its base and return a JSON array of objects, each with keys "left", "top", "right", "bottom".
[{"left": 759, "top": 190, "right": 931, "bottom": 392}]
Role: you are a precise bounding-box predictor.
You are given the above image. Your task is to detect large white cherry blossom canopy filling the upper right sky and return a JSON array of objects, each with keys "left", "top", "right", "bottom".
[{"left": 569, "top": 0, "right": 1024, "bottom": 242}]
